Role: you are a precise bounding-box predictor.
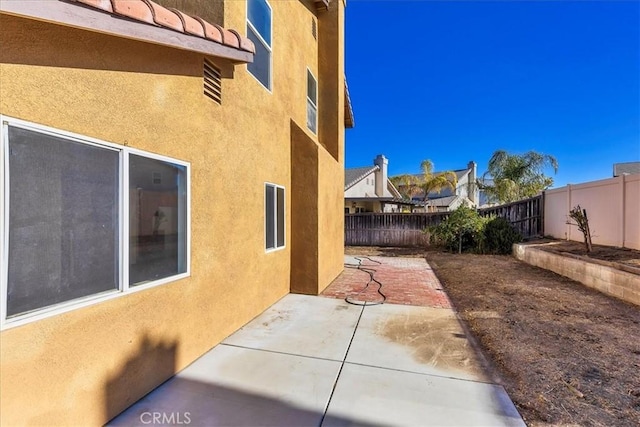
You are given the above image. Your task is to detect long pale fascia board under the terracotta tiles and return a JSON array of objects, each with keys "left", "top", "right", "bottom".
[{"left": 0, "top": 0, "right": 253, "bottom": 64}]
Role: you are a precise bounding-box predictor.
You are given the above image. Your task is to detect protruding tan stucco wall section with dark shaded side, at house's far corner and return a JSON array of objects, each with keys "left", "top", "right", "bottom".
[{"left": 291, "top": 2, "right": 344, "bottom": 295}]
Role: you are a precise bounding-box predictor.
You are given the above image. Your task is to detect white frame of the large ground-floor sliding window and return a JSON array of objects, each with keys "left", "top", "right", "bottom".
[{"left": 0, "top": 115, "right": 191, "bottom": 330}]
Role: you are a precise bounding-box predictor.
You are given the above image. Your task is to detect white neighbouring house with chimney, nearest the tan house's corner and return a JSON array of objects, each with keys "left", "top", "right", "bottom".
[{"left": 344, "top": 154, "right": 404, "bottom": 213}]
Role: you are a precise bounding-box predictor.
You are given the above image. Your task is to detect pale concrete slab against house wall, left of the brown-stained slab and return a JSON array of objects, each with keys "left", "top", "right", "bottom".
[{"left": 223, "top": 294, "right": 362, "bottom": 360}]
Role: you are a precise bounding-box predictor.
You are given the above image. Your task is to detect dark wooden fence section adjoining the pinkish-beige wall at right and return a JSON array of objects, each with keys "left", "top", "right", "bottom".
[{"left": 478, "top": 194, "right": 544, "bottom": 239}]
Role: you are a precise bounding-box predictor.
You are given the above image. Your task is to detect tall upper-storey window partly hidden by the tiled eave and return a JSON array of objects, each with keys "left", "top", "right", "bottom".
[{"left": 247, "top": 0, "right": 273, "bottom": 90}]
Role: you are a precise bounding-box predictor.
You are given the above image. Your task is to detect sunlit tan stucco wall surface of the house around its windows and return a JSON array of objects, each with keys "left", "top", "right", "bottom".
[{"left": 0, "top": 1, "right": 344, "bottom": 425}]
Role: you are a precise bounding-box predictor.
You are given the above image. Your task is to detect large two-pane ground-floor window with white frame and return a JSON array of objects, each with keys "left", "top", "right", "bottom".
[{"left": 0, "top": 116, "right": 190, "bottom": 328}]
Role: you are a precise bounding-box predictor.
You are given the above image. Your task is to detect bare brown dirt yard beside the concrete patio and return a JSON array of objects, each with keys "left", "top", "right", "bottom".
[{"left": 346, "top": 248, "right": 640, "bottom": 426}]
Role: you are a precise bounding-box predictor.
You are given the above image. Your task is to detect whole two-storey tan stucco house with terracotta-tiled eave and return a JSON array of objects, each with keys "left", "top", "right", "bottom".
[{"left": 0, "top": 0, "right": 353, "bottom": 425}]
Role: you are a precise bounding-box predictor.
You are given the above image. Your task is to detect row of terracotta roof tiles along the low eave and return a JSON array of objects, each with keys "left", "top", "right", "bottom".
[{"left": 74, "top": 0, "right": 256, "bottom": 54}]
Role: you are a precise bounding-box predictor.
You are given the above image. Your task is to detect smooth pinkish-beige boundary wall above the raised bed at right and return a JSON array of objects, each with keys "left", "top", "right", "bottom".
[{"left": 544, "top": 175, "right": 640, "bottom": 250}]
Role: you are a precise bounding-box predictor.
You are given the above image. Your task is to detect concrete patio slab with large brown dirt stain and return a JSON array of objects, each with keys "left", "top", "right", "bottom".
[{"left": 346, "top": 304, "right": 488, "bottom": 381}]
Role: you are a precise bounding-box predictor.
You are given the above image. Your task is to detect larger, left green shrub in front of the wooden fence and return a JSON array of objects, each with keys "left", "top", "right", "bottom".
[{"left": 427, "top": 206, "right": 490, "bottom": 253}]
